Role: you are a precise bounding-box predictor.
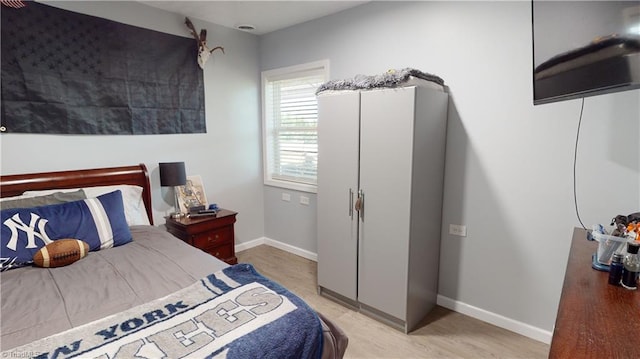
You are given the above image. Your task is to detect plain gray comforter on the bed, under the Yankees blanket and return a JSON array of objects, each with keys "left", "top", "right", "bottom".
[{"left": 0, "top": 226, "right": 347, "bottom": 357}]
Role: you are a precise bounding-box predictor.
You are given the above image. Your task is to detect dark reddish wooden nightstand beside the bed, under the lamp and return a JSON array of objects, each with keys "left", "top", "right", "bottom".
[{"left": 165, "top": 209, "right": 238, "bottom": 264}]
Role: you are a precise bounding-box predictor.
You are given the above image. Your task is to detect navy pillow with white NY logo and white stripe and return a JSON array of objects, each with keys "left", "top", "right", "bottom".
[{"left": 0, "top": 190, "right": 131, "bottom": 270}]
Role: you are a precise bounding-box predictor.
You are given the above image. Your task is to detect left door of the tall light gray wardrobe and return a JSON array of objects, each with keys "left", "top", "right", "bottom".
[{"left": 317, "top": 92, "right": 360, "bottom": 301}]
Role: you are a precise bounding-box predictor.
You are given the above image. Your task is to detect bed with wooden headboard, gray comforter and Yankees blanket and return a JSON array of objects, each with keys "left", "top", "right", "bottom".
[{"left": 0, "top": 164, "right": 348, "bottom": 358}]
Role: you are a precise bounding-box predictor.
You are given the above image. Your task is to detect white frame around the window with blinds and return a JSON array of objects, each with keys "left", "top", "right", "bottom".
[{"left": 261, "top": 60, "right": 329, "bottom": 193}]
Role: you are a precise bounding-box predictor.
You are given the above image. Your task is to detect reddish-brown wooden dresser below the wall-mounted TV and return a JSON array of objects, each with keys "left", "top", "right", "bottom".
[{"left": 549, "top": 228, "right": 640, "bottom": 359}]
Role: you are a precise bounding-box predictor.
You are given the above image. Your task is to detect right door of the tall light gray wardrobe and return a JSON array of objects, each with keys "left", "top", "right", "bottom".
[{"left": 358, "top": 87, "right": 416, "bottom": 321}]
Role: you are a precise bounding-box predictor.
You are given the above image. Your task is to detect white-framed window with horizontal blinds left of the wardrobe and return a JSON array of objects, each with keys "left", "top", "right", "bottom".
[{"left": 262, "top": 60, "right": 329, "bottom": 192}]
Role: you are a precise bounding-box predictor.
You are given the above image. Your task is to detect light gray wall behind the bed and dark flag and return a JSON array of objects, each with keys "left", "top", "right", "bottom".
[{"left": 0, "top": 1, "right": 264, "bottom": 242}]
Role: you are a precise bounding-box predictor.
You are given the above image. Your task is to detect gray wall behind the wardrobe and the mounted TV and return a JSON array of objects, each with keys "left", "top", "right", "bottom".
[{"left": 260, "top": 1, "right": 640, "bottom": 339}]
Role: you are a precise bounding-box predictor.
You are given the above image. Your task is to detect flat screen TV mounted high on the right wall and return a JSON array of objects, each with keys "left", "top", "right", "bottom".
[{"left": 532, "top": 0, "right": 640, "bottom": 105}]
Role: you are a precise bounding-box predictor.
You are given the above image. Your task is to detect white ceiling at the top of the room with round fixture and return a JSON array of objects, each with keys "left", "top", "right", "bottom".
[{"left": 140, "top": 1, "right": 368, "bottom": 35}]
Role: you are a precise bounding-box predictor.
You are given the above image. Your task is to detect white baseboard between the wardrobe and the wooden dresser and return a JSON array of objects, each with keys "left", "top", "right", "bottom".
[{"left": 437, "top": 294, "right": 553, "bottom": 344}]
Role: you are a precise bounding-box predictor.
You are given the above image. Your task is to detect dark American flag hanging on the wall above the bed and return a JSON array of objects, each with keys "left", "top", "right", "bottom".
[{"left": 0, "top": 1, "right": 206, "bottom": 135}]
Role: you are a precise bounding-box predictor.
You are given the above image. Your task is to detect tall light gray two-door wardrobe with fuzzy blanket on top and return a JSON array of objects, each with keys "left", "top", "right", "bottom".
[{"left": 317, "top": 86, "right": 448, "bottom": 333}]
